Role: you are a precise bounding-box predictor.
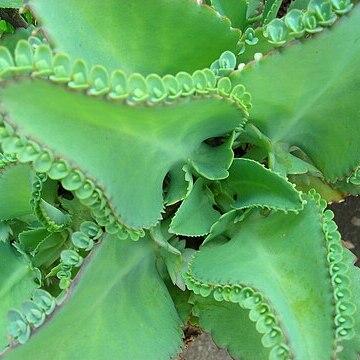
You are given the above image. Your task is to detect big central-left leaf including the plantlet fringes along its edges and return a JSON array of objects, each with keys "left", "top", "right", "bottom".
[{"left": 0, "top": 46, "right": 248, "bottom": 232}]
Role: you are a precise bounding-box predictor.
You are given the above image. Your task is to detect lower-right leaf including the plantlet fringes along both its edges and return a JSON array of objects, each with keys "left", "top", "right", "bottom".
[{"left": 187, "top": 191, "right": 358, "bottom": 360}]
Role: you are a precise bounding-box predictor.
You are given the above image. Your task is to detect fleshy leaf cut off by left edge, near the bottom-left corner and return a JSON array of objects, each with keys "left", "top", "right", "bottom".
[{"left": 0, "top": 242, "right": 38, "bottom": 352}]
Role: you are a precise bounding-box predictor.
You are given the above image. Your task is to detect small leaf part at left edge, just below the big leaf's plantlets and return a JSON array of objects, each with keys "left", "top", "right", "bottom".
[{"left": 0, "top": 163, "right": 33, "bottom": 220}]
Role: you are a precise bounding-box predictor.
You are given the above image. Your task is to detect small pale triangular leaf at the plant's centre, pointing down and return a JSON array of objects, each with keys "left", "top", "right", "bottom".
[{"left": 169, "top": 179, "right": 220, "bottom": 236}]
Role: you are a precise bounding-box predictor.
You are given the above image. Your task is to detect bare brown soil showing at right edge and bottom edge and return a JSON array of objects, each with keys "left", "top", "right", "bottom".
[{"left": 181, "top": 196, "right": 360, "bottom": 360}]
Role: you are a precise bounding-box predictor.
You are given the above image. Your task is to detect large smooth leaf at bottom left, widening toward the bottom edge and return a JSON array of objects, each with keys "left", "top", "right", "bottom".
[{"left": 7, "top": 237, "right": 182, "bottom": 360}]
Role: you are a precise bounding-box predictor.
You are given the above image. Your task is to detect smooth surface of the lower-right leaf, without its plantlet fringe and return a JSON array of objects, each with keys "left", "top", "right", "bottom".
[{"left": 190, "top": 197, "right": 348, "bottom": 360}]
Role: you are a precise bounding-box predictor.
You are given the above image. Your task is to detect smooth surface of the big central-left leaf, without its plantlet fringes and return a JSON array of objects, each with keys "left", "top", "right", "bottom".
[{"left": 2, "top": 80, "right": 244, "bottom": 228}]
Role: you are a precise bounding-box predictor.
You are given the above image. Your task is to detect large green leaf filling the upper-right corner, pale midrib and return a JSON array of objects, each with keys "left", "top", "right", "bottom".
[{"left": 233, "top": 5, "right": 360, "bottom": 181}]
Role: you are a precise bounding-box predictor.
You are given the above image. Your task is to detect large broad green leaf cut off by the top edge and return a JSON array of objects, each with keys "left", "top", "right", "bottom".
[{"left": 29, "top": 0, "right": 240, "bottom": 75}]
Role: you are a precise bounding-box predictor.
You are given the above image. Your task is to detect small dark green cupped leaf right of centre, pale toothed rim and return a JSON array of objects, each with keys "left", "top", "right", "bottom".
[{"left": 216, "top": 158, "right": 303, "bottom": 211}]
